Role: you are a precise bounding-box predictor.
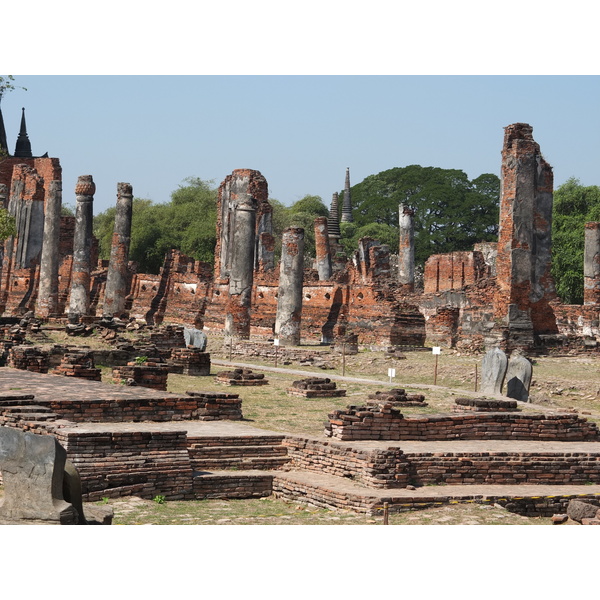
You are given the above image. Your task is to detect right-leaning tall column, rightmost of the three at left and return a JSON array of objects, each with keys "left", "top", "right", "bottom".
[{"left": 102, "top": 183, "right": 133, "bottom": 317}]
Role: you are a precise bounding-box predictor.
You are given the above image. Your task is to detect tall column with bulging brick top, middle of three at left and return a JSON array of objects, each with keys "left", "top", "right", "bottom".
[{"left": 69, "top": 175, "right": 96, "bottom": 322}]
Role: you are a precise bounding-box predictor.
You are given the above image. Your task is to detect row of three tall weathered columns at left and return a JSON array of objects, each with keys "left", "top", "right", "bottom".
[{"left": 36, "top": 175, "right": 133, "bottom": 322}]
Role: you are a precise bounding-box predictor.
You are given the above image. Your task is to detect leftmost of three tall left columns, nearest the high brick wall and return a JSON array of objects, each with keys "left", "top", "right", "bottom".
[{"left": 36, "top": 180, "right": 62, "bottom": 317}]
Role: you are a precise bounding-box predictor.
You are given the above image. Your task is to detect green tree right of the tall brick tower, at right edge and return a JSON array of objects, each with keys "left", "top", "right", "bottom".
[{"left": 552, "top": 177, "right": 600, "bottom": 304}]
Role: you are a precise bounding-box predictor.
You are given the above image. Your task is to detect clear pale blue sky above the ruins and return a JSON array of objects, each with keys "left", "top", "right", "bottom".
[{"left": 2, "top": 75, "right": 600, "bottom": 212}]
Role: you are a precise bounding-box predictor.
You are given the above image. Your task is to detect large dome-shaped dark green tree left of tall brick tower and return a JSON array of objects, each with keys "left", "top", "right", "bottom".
[{"left": 340, "top": 165, "right": 500, "bottom": 264}]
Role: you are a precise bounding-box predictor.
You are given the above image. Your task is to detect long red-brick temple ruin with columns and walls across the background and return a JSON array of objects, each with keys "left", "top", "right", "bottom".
[{"left": 0, "top": 114, "right": 600, "bottom": 351}]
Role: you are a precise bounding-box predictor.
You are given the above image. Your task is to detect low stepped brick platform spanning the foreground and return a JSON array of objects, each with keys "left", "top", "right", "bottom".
[{"left": 0, "top": 368, "right": 600, "bottom": 516}]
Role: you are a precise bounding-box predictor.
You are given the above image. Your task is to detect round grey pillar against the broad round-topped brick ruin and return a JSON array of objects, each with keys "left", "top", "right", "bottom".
[{"left": 224, "top": 194, "right": 256, "bottom": 340}]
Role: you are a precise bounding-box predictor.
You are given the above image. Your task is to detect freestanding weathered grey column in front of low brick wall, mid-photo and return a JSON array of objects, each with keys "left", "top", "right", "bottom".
[{"left": 275, "top": 227, "right": 304, "bottom": 346}]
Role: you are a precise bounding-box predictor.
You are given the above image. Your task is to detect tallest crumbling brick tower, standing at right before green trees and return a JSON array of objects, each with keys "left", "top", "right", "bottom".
[{"left": 494, "top": 123, "right": 557, "bottom": 350}]
